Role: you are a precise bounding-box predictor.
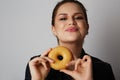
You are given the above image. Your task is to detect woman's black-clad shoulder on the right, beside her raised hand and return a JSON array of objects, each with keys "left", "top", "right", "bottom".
[{"left": 92, "top": 57, "right": 115, "bottom": 80}]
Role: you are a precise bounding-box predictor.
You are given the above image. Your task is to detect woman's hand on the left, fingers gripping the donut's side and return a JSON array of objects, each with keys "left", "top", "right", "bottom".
[{"left": 29, "top": 49, "right": 53, "bottom": 80}]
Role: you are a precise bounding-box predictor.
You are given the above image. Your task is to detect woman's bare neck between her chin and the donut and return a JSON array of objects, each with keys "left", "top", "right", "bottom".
[{"left": 60, "top": 43, "right": 82, "bottom": 59}]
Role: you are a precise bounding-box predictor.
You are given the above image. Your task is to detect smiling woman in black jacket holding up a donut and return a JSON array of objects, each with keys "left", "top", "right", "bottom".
[{"left": 25, "top": 0, "right": 115, "bottom": 80}]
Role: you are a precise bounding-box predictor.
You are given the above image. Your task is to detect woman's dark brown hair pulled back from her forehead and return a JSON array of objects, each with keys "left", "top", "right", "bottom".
[{"left": 51, "top": 0, "right": 88, "bottom": 26}]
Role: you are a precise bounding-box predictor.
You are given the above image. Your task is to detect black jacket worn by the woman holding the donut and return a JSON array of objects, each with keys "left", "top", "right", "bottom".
[{"left": 25, "top": 50, "right": 115, "bottom": 80}]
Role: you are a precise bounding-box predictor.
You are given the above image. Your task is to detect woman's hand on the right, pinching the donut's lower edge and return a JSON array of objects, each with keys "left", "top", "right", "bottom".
[{"left": 61, "top": 55, "right": 93, "bottom": 80}]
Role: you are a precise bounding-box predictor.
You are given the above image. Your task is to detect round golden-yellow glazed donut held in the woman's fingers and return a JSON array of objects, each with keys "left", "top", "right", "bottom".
[{"left": 48, "top": 46, "right": 72, "bottom": 70}]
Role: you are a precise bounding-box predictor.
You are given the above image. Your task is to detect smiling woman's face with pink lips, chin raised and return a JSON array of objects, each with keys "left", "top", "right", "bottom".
[{"left": 52, "top": 3, "right": 89, "bottom": 43}]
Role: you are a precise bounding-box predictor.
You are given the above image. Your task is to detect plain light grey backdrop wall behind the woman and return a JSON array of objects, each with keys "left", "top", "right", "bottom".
[{"left": 0, "top": 0, "right": 120, "bottom": 80}]
